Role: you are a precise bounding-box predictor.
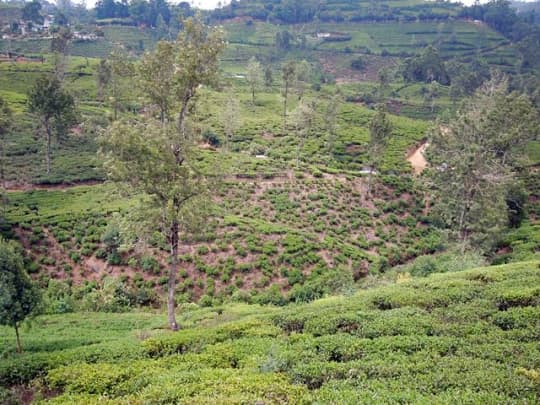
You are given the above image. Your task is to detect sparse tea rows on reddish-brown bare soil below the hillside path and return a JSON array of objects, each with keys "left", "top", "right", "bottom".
[{"left": 6, "top": 164, "right": 442, "bottom": 303}]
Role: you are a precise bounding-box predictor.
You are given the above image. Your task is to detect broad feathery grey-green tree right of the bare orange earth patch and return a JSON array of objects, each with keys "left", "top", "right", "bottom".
[{"left": 426, "top": 76, "right": 539, "bottom": 249}]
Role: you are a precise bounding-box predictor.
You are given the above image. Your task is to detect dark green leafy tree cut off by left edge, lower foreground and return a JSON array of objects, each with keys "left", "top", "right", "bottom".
[{"left": 0, "top": 237, "right": 40, "bottom": 353}]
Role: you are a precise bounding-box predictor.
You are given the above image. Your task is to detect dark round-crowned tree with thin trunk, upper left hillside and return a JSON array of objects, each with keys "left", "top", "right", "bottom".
[{"left": 28, "top": 76, "right": 76, "bottom": 174}]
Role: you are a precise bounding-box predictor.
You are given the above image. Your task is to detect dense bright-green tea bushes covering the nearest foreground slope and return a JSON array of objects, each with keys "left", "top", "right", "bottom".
[{"left": 0, "top": 261, "right": 540, "bottom": 404}]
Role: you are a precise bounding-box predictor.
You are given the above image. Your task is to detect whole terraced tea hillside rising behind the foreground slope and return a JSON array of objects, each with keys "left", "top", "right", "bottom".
[{"left": 0, "top": 1, "right": 540, "bottom": 309}]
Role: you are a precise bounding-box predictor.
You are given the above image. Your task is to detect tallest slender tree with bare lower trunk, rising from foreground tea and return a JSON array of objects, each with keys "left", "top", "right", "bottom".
[{"left": 103, "top": 18, "right": 224, "bottom": 330}]
